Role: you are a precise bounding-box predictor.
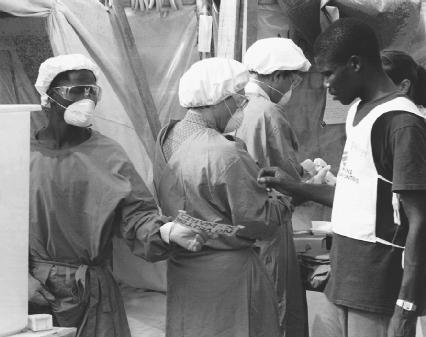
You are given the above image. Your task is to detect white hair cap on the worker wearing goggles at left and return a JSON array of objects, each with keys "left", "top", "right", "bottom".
[{"left": 34, "top": 54, "right": 99, "bottom": 105}]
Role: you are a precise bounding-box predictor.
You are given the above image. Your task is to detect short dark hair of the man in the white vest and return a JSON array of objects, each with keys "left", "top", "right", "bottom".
[{"left": 314, "top": 18, "right": 381, "bottom": 66}]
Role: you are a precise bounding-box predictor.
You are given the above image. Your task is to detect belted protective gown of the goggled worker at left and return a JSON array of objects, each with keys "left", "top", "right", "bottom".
[{"left": 30, "top": 131, "right": 168, "bottom": 337}]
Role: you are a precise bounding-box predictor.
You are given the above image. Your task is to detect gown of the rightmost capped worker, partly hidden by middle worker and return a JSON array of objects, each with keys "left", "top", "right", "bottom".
[{"left": 236, "top": 82, "right": 309, "bottom": 337}]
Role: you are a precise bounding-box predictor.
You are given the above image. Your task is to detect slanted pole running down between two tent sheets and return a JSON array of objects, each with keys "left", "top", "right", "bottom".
[{"left": 112, "top": 0, "right": 161, "bottom": 136}]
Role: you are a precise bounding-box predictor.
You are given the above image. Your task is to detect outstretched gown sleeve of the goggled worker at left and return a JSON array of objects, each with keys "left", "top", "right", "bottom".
[{"left": 119, "top": 161, "right": 170, "bottom": 262}]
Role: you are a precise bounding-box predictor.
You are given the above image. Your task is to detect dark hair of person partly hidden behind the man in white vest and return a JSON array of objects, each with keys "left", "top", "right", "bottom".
[{"left": 381, "top": 50, "right": 426, "bottom": 106}]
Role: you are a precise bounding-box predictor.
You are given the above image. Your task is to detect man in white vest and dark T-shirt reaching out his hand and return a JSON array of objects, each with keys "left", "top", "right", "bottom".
[{"left": 259, "top": 19, "right": 426, "bottom": 337}]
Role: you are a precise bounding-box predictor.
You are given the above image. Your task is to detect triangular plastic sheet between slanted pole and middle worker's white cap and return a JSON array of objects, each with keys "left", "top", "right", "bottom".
[{"left": 126, "top": 6, "right": 199, "bottom": 125}]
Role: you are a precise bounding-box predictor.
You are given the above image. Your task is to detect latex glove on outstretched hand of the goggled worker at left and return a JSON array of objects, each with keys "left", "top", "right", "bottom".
[{"left": 160, "top": 222, "right": 208, "bottom": 252}]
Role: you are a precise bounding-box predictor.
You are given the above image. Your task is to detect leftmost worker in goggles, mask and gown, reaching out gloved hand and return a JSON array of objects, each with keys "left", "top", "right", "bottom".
[{"left": 29, "top": 55, "right": 205, "bottom": 337}]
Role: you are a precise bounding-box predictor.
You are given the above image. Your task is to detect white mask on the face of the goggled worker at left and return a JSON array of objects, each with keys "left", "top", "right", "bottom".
[{"left": 50, "top": 97, "right": 96, "bottom": 128}]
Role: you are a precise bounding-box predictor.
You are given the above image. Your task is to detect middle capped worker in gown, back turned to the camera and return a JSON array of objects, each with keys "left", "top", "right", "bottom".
[{"left": 154, "top": 58, "right": 281, "bottom": 337}]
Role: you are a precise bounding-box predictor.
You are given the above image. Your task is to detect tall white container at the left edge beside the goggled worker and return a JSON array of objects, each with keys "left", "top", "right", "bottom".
[{"left": 0, "top": 105, "right": 33, "bottom": 336}]
